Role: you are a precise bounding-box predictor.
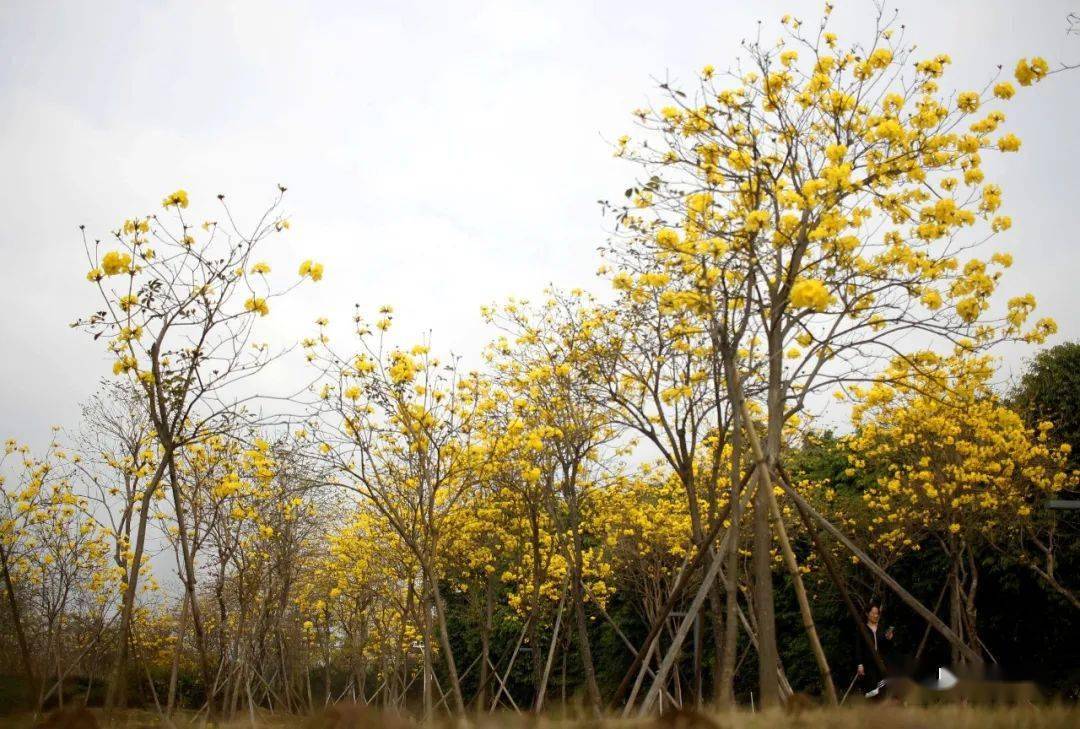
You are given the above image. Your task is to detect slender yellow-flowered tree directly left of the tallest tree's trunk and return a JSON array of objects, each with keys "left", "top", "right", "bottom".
[{"left": 586, "top": 270, "right": 740, "bottom": 701}]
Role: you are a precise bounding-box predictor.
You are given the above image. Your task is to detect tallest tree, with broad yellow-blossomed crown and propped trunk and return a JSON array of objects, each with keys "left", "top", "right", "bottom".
[{"left": 615, "top": 4, "right": 1055, "bottom": 705}]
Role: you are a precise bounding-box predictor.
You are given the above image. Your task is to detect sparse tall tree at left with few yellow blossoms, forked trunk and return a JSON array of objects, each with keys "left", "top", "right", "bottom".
[{"left": 72, "top": 187, "right": 323, "bottom": 706}]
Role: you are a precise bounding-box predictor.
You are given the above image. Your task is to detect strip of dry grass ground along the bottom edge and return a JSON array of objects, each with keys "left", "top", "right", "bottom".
[{"left": 6, "top": 704, "right": 1080, "bottom": 729}]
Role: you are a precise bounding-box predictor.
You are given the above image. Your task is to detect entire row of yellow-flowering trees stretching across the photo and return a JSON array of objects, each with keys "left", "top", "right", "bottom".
[{"left": 0, "top": 5, "right": 1077, "bottom": 715}]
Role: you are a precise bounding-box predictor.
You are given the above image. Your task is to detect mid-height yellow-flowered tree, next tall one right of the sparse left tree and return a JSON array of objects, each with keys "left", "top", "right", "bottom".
[{"left": 310, "top": 308, "right": 488, "bottom": 715}]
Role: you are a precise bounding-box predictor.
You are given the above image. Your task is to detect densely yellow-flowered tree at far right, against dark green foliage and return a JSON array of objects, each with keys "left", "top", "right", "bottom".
[{"left": 849, "top": 352, "right": 1076, "bottom": 661}]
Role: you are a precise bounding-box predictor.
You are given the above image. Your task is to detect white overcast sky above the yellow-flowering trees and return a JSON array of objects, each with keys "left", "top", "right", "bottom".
[{"left": 0, "top": 0, "right": 1080, "bottom": 442}]
